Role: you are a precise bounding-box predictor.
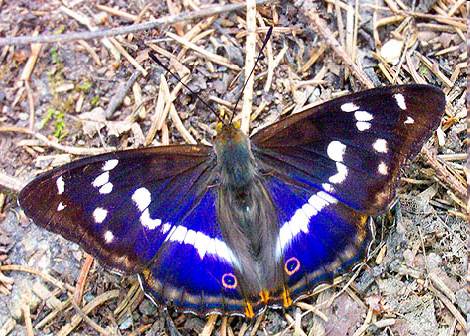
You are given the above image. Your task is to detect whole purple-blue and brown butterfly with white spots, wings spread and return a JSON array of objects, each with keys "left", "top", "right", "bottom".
[{"left": 19, "top": 85, "right": 445, "bottom": 318}]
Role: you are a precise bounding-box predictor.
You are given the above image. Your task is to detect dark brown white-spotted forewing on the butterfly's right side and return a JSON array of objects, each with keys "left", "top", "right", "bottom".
[{"left": 251, "top": 85, "right": 445, "bottom": 215}]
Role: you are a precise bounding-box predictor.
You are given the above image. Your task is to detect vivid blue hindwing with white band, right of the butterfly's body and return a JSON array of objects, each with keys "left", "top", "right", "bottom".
[{"left": 265, "top": 174, "right": 371, "bottom": 300}]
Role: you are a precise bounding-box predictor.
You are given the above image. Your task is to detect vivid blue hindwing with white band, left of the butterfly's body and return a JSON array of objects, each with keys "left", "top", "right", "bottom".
[{"left": 140, "top": 188, "right": 243, "bottom": 314}]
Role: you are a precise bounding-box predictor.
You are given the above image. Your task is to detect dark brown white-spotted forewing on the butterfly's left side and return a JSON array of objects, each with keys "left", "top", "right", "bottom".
[{"left": 19, "top": 146, "right": 214, "bottom": 273}]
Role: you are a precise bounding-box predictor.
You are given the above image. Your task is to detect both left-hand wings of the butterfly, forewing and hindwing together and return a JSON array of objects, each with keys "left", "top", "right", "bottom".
[{"left": 19, "top": 146, "right": 242, "bottom": 313}]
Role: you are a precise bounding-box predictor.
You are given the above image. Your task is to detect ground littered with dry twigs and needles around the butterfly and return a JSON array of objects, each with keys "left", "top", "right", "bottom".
[{"left": 0, "top": 0, "right": 468, "bottom": 336}]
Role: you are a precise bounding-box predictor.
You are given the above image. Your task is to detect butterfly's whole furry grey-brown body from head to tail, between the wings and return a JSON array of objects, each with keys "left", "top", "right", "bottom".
[{"left": 215, "top": 126, "right": 283, "bottom": 297}]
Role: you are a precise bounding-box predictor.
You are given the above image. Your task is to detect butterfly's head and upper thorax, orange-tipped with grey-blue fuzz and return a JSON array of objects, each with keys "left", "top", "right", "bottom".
[{"left": 214, "top": 121, "right": 256, "bottom": 189}]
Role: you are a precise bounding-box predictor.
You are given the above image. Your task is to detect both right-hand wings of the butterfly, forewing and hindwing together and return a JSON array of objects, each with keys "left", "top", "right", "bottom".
[{"left": 251, "top": 85, "right": 445, "bottom": 299}]
